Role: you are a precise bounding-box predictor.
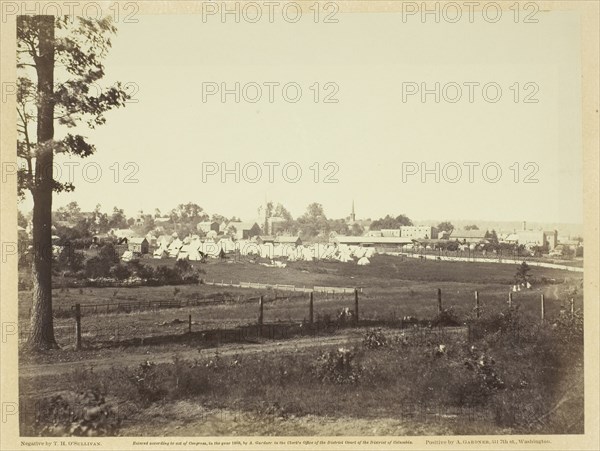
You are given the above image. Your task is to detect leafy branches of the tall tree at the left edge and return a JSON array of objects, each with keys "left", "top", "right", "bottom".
[{"left": 16, "top": 16, "right": 129, "bottom": 197}]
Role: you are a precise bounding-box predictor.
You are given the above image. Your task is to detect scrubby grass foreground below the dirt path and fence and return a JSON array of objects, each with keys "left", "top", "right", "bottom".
[{"left": 20, "top": 310, "right": 584, "bottom": 436}]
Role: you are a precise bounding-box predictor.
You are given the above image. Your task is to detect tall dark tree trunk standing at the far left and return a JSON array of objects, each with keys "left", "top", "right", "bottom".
[{"left": 28, "top": 16, "right": 58, "bottom": 350}]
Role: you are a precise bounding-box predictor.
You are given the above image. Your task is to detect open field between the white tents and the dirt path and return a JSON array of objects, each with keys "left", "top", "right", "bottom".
[{"left": 19, "top": 255, "right": 582, "bottom": 347}]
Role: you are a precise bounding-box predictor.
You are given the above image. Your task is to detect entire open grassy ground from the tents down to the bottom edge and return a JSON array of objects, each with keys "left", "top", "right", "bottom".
[{"left": 19, "top": 255, "right": 583, "bottom": 435}]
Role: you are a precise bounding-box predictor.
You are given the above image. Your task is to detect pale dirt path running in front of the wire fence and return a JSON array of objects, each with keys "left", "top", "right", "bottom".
[{"left": 19, "top": 330, "right": 360, "bottom": 378}]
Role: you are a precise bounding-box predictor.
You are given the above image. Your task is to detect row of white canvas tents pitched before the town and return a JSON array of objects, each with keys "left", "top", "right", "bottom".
[{"left": 153, "top": 238, "right": 375, "bottom": 265}]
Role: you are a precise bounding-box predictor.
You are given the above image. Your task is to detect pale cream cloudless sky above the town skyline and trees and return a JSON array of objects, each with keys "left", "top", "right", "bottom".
[{"left": 18, "top": 8, "right": 583, "bottom": 223}]
